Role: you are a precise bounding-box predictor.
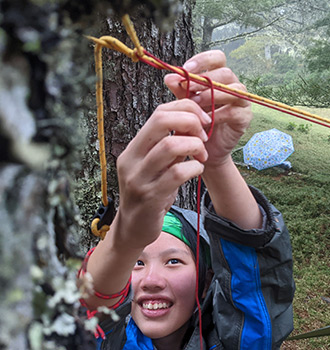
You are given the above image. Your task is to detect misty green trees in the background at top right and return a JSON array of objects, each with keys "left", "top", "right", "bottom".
[{"left": 194, "top": 0, "right": 330, "bottom": 107}]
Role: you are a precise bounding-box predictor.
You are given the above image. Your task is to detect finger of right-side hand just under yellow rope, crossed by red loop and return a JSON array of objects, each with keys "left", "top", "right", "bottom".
[{"left": 190, "top": 83, "right": 249, "bottom": 111}]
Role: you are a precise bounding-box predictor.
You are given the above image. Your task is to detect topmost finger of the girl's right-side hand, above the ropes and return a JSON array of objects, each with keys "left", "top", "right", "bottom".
[{"left": 183, "top": 50, "right": 226, "bottom": 74}]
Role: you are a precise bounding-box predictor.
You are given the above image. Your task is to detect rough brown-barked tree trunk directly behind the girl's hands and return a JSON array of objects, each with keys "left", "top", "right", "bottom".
[{"left": 81, "top": 1, "right": 196, "bottom": 235}]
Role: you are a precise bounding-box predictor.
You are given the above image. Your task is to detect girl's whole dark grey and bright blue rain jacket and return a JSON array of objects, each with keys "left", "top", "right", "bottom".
[{"left": 98, "top": 187, "right": 295, "bottom": 350}]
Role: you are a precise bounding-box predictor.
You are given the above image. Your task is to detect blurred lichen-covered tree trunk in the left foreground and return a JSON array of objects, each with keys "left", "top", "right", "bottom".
[{"left": 0, "top": 0, "right": 102, "bottom": 350}]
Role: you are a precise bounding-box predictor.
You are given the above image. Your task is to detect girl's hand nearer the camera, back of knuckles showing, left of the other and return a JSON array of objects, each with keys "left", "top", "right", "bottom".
[{"left": 116, "top": 99, "right": 211, "bottom": 249}]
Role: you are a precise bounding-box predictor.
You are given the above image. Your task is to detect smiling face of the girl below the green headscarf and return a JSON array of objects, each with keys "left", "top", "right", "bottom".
[{"left": 131, "top": 232, "right": 196, "bottom": 339}]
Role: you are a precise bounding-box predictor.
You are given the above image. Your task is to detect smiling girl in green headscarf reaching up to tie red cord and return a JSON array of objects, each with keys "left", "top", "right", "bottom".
[{"left": 79, "top": 51, "right": 294, "bottom": 350}]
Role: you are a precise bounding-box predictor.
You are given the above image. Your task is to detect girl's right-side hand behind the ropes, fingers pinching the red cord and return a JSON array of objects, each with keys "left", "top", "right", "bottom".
[{"left": 165, "top": 50, "right": 252, "bottom": 170}]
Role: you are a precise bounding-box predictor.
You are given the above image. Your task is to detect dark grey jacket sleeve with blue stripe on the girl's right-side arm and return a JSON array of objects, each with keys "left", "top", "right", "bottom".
[{"left": 203, "top": 187, "right": 295, "bottom": 350}]
